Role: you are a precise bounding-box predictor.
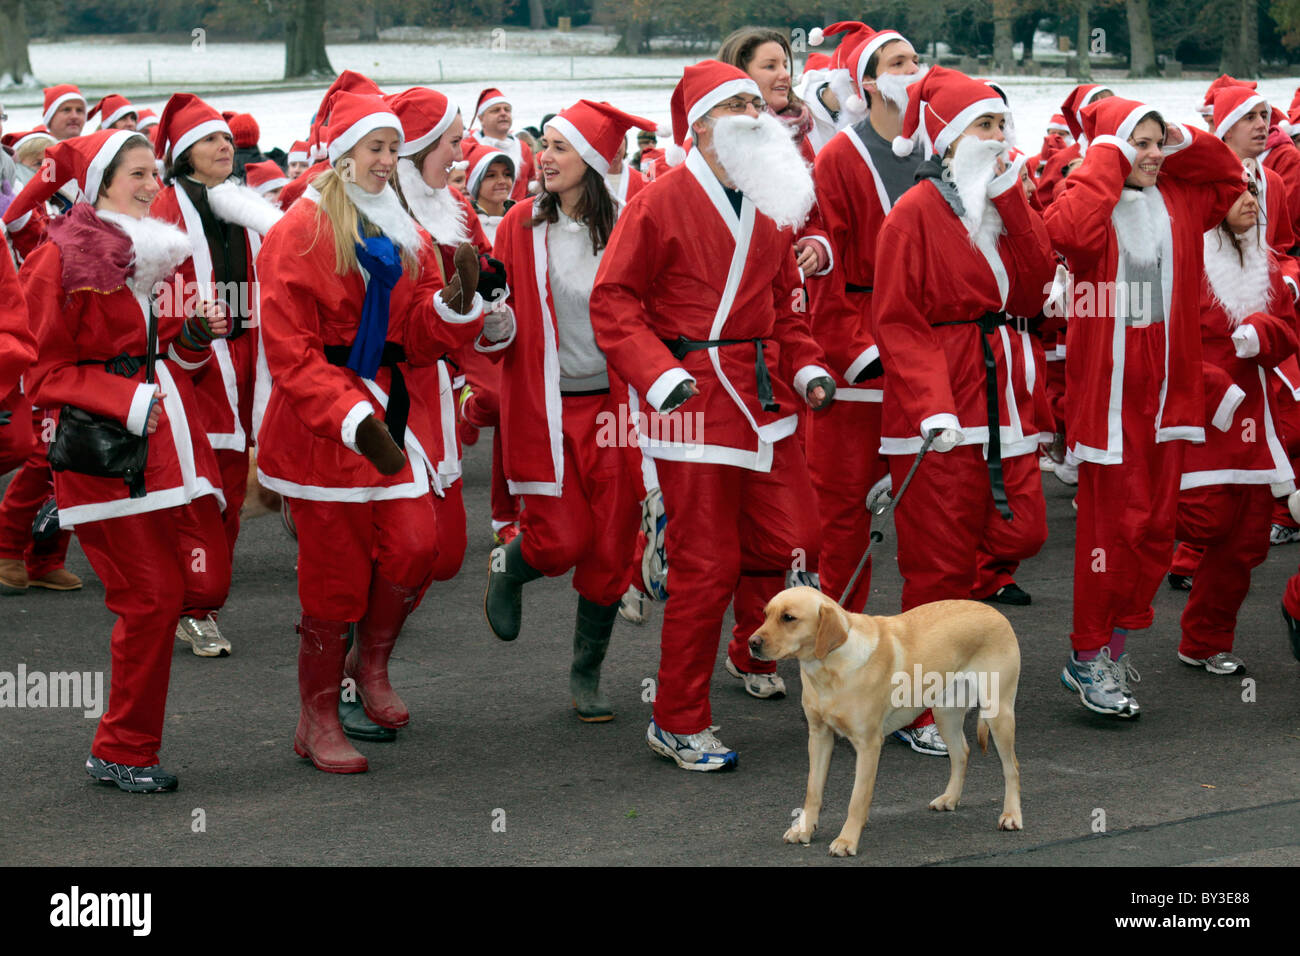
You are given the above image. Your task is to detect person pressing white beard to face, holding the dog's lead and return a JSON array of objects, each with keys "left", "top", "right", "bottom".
[{"left": 871, "top": 66, "right": 1054, "bottom": 671}]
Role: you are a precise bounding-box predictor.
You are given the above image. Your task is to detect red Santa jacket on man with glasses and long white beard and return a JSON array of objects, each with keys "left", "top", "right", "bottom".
[{"left": 587, "top": 150, "right": 828, "bottom": 471}]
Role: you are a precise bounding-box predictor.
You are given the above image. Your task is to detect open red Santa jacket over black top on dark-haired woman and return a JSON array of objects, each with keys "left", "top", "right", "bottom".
[{"left": 150, "top": 186, "right": 270, "bottom": 451}]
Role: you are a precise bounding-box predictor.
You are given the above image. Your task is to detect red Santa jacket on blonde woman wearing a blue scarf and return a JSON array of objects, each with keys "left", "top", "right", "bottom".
[{"left": 257, "top": 187, "right": 482, "bottom": 501}]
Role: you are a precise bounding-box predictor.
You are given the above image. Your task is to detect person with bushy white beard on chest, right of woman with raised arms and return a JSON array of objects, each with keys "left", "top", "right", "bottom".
[{"left": 1177, "top": 174, "right": 1297, "bottom": 674}]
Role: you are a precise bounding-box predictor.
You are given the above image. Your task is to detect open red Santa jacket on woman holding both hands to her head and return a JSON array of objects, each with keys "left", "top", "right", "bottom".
[{"left": 1044, "top": 126, "right": 1244, "bottom": 464}]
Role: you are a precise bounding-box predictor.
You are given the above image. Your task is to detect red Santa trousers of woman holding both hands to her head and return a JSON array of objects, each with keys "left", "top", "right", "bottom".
[{"left": 1070, "top": 323, "right": 1184, "bottom": 652}]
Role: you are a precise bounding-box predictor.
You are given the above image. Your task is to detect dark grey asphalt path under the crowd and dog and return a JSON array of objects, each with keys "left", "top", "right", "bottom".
[{"left": 0, "top": 442, "right": 1300, "bottom": 866}]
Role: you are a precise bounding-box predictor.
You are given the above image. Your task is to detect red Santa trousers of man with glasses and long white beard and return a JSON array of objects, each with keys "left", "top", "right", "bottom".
[{"left": 654, "top": 436, "right": 816, "bottom": 734}]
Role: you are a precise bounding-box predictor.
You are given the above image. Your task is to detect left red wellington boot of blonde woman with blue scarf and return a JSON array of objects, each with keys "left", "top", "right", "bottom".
[{"left": 294, "top": 614, "right": 369, "bottom": 774}]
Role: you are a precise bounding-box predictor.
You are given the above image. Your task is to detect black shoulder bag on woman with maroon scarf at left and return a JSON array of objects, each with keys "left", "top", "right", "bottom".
[{"left": 49, "top": 304, "right": 157, "bottom": 498}]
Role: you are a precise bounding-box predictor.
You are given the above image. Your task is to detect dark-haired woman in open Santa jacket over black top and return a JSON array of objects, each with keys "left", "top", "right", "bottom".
[{"left": 150, "top": 92, "right": 281, "bottom": 657}]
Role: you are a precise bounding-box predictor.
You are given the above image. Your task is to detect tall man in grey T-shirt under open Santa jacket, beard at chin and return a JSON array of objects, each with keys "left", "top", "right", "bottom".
[{"left": 807, "top": 25, "right": 948, "bottom": 756}]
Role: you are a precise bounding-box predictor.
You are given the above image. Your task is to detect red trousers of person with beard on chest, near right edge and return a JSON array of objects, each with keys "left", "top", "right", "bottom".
[{"left": 1177, "top": 485, "right": 1273, "bottom": 659}]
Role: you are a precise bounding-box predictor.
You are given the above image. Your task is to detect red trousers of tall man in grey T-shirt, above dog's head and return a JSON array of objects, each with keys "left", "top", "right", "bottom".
[{"left": 806, "top": 401, "right": 889, "bottom": 613}]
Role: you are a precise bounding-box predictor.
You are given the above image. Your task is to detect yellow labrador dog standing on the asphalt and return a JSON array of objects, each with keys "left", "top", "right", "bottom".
[{"left": 749, "top": 588, "right": 1023, "bottom": 856}]
